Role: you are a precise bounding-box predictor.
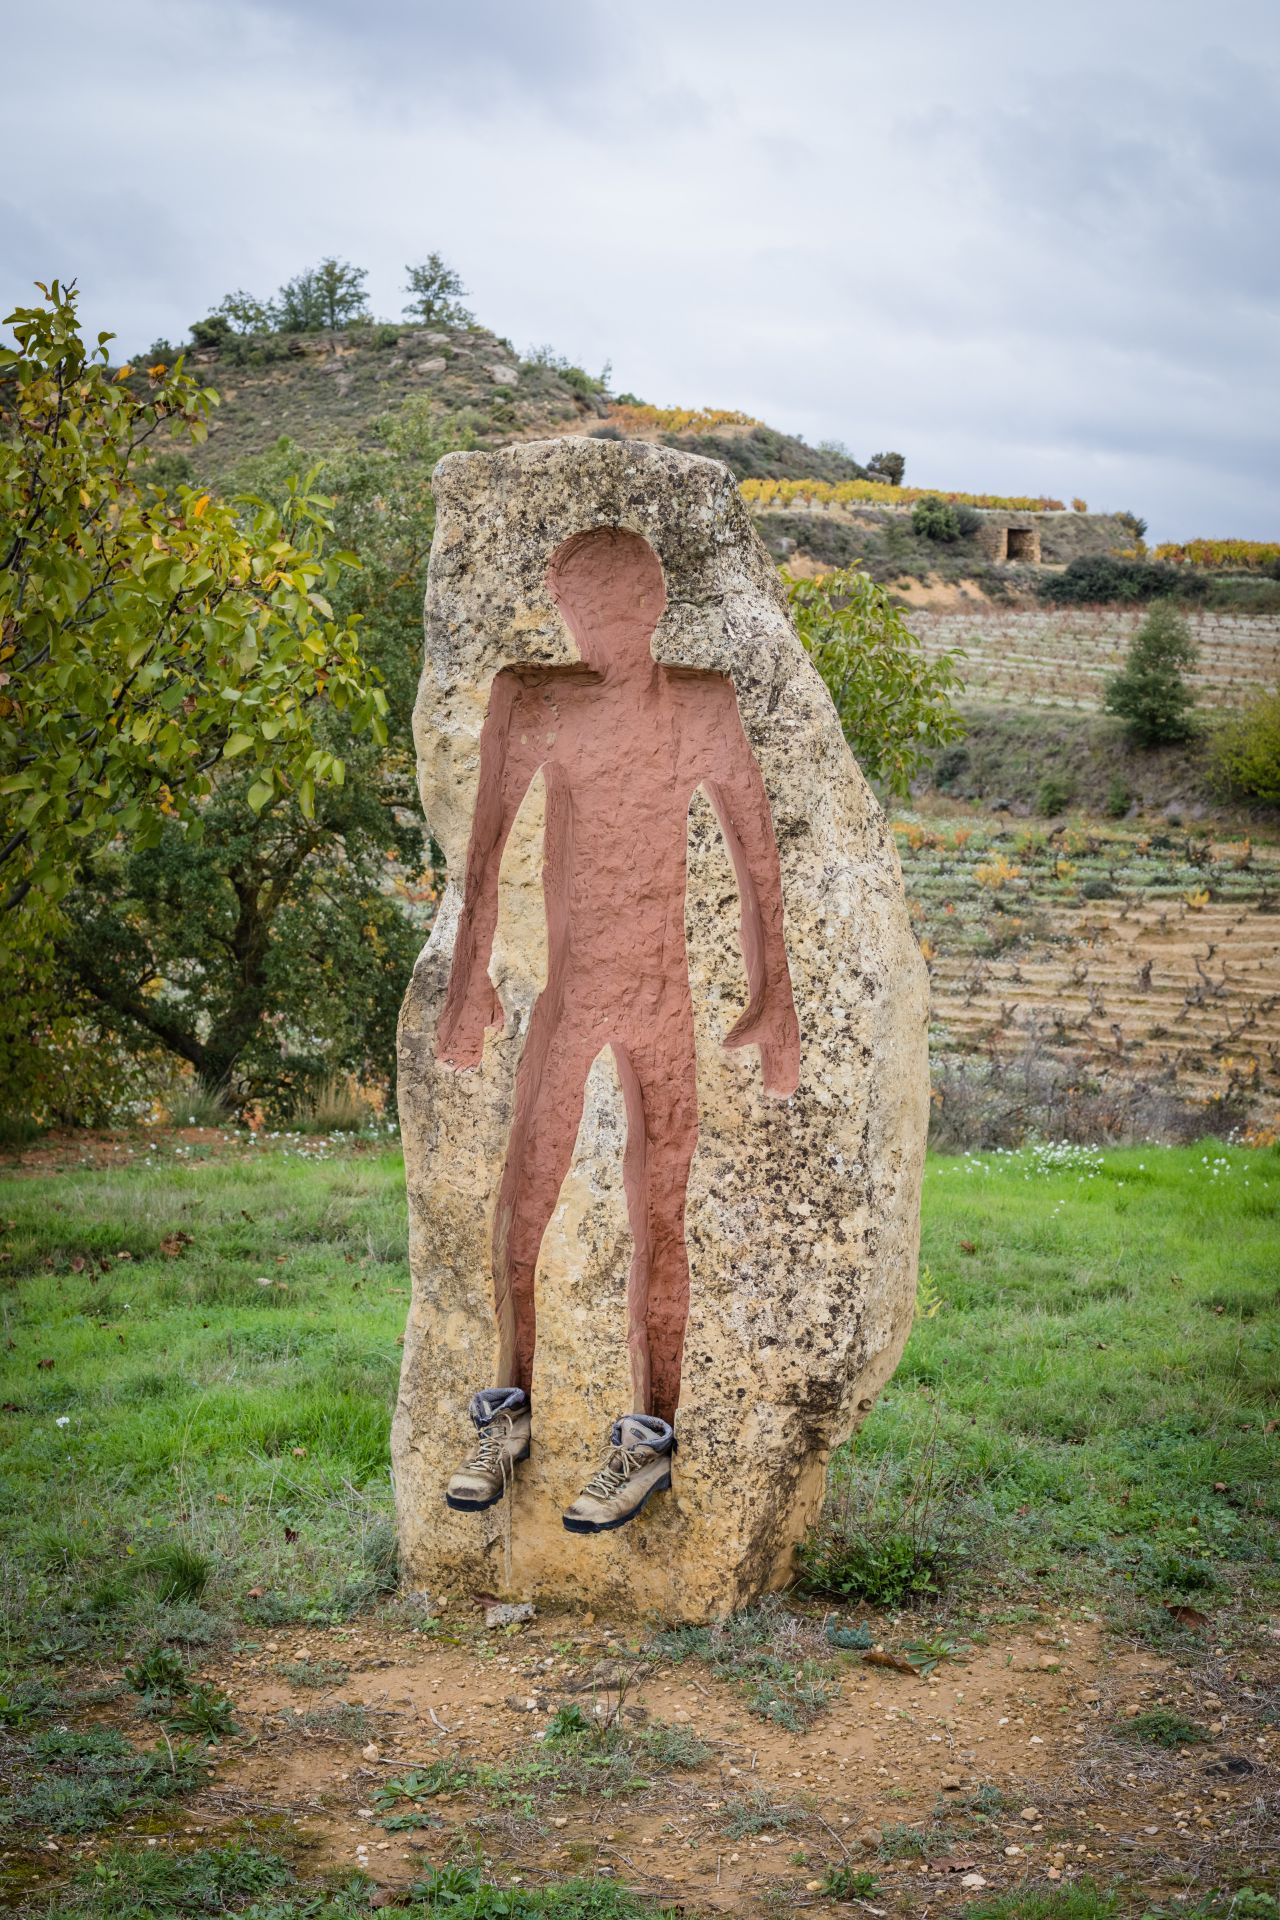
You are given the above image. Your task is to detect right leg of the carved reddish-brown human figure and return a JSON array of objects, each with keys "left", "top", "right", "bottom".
[{"left": 614, "top": 1008, "right": 699, "bottom": 1423}]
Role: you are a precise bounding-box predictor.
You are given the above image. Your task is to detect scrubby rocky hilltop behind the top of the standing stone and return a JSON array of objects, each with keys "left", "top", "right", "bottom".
[{"left": 163, "top": 323, "right": 1134, "bottom": 579}]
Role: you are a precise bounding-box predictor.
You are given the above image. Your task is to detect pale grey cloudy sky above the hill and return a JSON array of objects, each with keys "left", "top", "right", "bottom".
[{"left": 0, "top": 0, "right": 1280, "bottom": 538}]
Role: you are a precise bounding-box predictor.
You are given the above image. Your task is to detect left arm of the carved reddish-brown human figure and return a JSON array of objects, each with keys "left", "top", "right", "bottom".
[{"left": 436, "top": 672, "right": 537, "bottom": 1068}]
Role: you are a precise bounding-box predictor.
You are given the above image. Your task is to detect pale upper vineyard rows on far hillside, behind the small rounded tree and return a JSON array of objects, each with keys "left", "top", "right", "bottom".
[{"left": 908, "top": 607, "right": 1280, "bottom": 708}]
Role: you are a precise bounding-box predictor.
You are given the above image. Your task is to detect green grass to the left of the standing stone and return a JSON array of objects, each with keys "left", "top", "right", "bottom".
[{"left": 0, "top": 1146, "right": 409, "bottom": 1655}]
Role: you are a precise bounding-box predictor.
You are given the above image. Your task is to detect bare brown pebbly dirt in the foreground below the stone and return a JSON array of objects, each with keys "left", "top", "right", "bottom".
[{"left": 40, "top": 1613, "right": 1278, "bottom": 1914}]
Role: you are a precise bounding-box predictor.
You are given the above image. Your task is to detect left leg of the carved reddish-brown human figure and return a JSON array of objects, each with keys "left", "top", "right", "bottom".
[{"left": 493, "top": 995, "right": 597, "bottom": 1394}]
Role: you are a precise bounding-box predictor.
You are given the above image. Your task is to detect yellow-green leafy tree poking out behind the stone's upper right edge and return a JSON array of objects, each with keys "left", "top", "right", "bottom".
[{"left": 789, "top": 566, "right": 965, "bottom": 795}]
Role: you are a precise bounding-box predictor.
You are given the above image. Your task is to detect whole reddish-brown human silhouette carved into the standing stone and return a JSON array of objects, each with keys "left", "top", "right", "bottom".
[{"left": 436, "top": 528, "right": 800, "bottom": 1421}]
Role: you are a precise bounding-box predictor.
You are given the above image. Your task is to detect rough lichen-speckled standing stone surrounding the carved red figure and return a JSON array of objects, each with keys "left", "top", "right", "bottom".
[{"left": 391, "top": 440, "right": 929, "bottom": 1620}]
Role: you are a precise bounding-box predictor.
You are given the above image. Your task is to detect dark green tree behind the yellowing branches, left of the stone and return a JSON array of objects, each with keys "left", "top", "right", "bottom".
[{"left": 59, "top": 403, "right": 466, "bottom": 1112}]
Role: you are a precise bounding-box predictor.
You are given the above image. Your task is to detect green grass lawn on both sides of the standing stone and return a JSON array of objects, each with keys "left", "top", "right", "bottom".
[{"left": 0, "top": 1144, "right": 1280, "bottom": 1658}]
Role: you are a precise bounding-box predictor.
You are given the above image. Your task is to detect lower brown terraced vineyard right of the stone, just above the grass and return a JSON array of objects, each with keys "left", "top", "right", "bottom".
[{"left": 894, "top": 820, "right": 1280, "bottom": 1117}]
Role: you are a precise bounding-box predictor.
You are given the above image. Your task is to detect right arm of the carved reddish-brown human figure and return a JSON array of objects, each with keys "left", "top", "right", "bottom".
[{"left": 706, "top": 687, "right": 800, "bottom": 1094}]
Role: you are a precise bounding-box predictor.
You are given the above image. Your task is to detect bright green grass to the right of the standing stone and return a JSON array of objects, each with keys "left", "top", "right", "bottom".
[{"left": 821, "top": 1142, "right": 1280, "bottom": 1636}]
